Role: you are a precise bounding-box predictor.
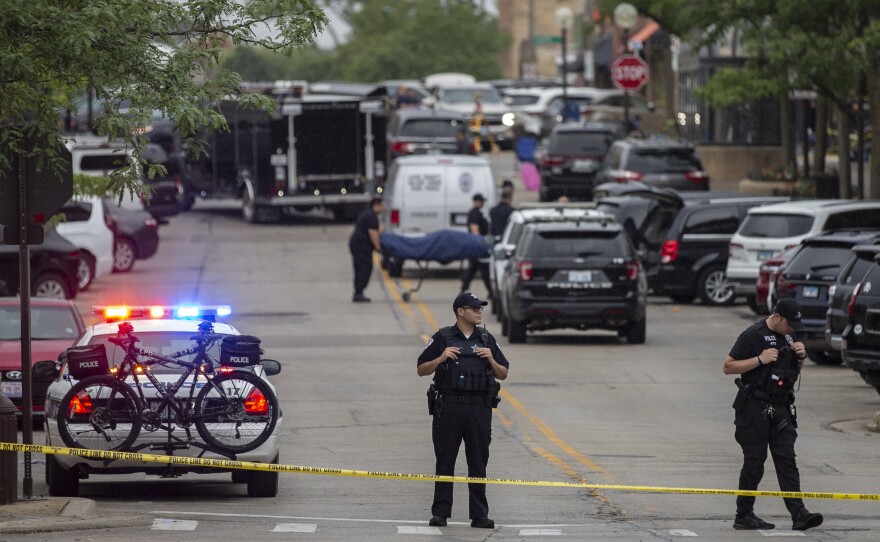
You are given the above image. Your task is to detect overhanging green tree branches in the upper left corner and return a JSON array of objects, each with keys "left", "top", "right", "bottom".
[{"left": 0, "top": 0, "right": 327, "bottom": 200}]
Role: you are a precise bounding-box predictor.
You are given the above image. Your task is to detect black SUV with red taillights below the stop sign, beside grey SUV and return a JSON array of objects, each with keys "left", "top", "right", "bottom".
[{"left": 538, "top": 122, "right": 619, "bottom": 201}]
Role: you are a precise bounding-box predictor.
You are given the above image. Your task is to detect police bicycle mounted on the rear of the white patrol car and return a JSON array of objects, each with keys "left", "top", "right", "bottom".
[{"left": 57, "top": 321, "right": 279, "bottom": 458}]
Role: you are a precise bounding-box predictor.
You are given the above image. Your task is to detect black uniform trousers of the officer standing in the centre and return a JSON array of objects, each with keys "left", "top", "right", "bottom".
[{"left": 431, "top": 396, "right": 492, "bottom": 519}]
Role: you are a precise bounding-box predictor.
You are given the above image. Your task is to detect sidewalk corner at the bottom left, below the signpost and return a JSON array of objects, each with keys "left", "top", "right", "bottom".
[{"left": 0, "top": 497, "right": 153, "bottom": 535}]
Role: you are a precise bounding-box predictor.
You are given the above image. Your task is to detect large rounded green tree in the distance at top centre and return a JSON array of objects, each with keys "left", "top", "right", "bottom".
[{"left": 337, "top": 0, "right": 510, "bottom": 81}]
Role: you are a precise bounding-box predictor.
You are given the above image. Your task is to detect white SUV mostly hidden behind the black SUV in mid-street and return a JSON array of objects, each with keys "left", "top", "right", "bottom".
[{"left": 489, "top": 203, "right": 600, "bottom": 320}]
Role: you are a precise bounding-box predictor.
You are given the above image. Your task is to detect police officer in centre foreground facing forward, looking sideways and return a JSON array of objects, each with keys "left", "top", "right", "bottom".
[{"left": 418, "top": 292, "right": 510, "bottom": 529}]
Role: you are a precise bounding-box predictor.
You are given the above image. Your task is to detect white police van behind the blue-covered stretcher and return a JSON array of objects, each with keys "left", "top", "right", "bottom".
[{"left": 382, "top": 154, "right": 498, "bottom": 236}]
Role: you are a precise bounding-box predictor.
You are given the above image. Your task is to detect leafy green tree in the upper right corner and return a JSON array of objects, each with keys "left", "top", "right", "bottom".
[{"left": 603, "top": 0, "right": 880, "bottom": 198}]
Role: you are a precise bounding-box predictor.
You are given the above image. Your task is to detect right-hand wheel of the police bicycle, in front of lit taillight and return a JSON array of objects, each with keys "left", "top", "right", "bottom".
[{"left": 193, "top": 371, "right": 278, "bottom": 453}]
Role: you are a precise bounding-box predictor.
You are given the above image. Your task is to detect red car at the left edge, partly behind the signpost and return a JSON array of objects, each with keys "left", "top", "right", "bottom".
[{"left": 0, "top": 297, "right": 86, "bottom": 420}]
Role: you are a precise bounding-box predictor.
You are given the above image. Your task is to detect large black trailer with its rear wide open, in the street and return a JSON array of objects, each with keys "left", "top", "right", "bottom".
[{"left": 189, "top": 83, "right": 386, "bottom": 223}]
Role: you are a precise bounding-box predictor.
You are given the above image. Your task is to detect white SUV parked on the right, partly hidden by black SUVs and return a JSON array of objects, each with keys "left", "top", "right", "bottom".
[{"left": 727, "top": 200, "right": 880, "bottom": 312}]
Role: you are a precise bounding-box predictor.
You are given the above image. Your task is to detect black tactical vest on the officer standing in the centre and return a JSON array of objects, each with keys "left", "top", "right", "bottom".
[{"left": 434, "top": 326, "right": 500, "bottom": 395}]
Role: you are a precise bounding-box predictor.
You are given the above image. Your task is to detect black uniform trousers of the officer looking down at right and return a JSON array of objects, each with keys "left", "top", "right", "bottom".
[{"left": 735, "top": 399, "right": 804, "bottom": 517}]
